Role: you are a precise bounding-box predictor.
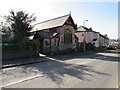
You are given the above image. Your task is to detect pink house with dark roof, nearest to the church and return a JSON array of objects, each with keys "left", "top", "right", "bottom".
[{"left": 75, "top": 26, "right": 99, "bottom": 51}]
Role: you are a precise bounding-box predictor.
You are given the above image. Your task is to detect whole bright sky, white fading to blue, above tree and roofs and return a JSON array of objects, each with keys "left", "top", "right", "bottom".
[{"left": 0, "top": 0, "right": 118, "bottom": 39}]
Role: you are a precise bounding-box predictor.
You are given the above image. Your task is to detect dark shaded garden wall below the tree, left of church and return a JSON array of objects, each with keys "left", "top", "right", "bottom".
[{"left": 2, "top": 45, "right": 37, "bottom": 60}]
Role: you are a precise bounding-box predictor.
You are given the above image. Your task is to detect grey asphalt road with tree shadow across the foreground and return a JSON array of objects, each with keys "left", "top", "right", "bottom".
[{"left": 2, "top": 51, "right": 118, "bottom": 88}]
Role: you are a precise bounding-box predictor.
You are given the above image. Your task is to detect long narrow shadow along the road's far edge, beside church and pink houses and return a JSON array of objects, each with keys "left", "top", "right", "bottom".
[{"left": 49, "top": 50, "right": 120, "bottom": 62}]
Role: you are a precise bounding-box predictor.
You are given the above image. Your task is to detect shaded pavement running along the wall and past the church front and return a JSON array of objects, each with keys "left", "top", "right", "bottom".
[{"left": 2, "top": 51, "right": 95, "bottom": 69}]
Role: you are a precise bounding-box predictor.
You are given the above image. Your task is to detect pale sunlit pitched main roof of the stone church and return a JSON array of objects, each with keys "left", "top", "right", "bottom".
[{"left": 30, "top": 14, "right": 71, "bottom": 32}]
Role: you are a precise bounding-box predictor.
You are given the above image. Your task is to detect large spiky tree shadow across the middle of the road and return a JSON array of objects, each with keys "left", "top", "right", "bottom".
[{"left": 23, "top": 55, "right": 111, "bottom": 84}]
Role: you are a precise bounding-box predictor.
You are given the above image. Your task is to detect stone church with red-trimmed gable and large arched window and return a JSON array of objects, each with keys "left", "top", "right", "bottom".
[{"left": 30, "top": 14, "right": 77, "bottom": 54}]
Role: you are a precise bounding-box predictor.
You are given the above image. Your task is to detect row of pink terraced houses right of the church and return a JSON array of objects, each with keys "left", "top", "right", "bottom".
[{"left": 75, "top": 26, "right": 109, "bottom": 51}]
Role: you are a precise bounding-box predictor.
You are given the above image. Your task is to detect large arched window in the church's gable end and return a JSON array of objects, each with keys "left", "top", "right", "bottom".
[{"left": 64, "top": 29, "right": 72, "bottom": 44}]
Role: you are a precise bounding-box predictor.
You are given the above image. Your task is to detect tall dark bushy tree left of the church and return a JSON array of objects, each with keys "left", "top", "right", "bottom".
[{"left": 5, "top": 10, "right": 36, "bottom": 43}]
